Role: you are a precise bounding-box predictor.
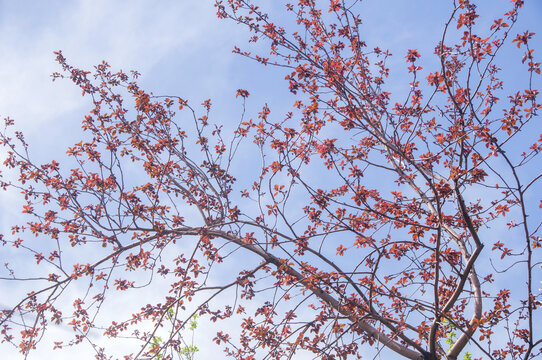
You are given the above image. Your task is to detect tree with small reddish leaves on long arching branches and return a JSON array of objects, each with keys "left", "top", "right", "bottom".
[{"left": 1, "top": 0, "right": 542, "bottom": 359}]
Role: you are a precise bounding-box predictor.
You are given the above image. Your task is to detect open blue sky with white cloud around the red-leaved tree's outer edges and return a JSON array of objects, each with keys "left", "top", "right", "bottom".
[{"left": 0, "top": 0, "right": 542, "bottom": 359}]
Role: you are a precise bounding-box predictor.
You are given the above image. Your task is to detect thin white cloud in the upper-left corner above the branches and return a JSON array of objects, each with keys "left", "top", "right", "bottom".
[{"left": 0, "top": 0, "right": 232, "bottom": 131}]
